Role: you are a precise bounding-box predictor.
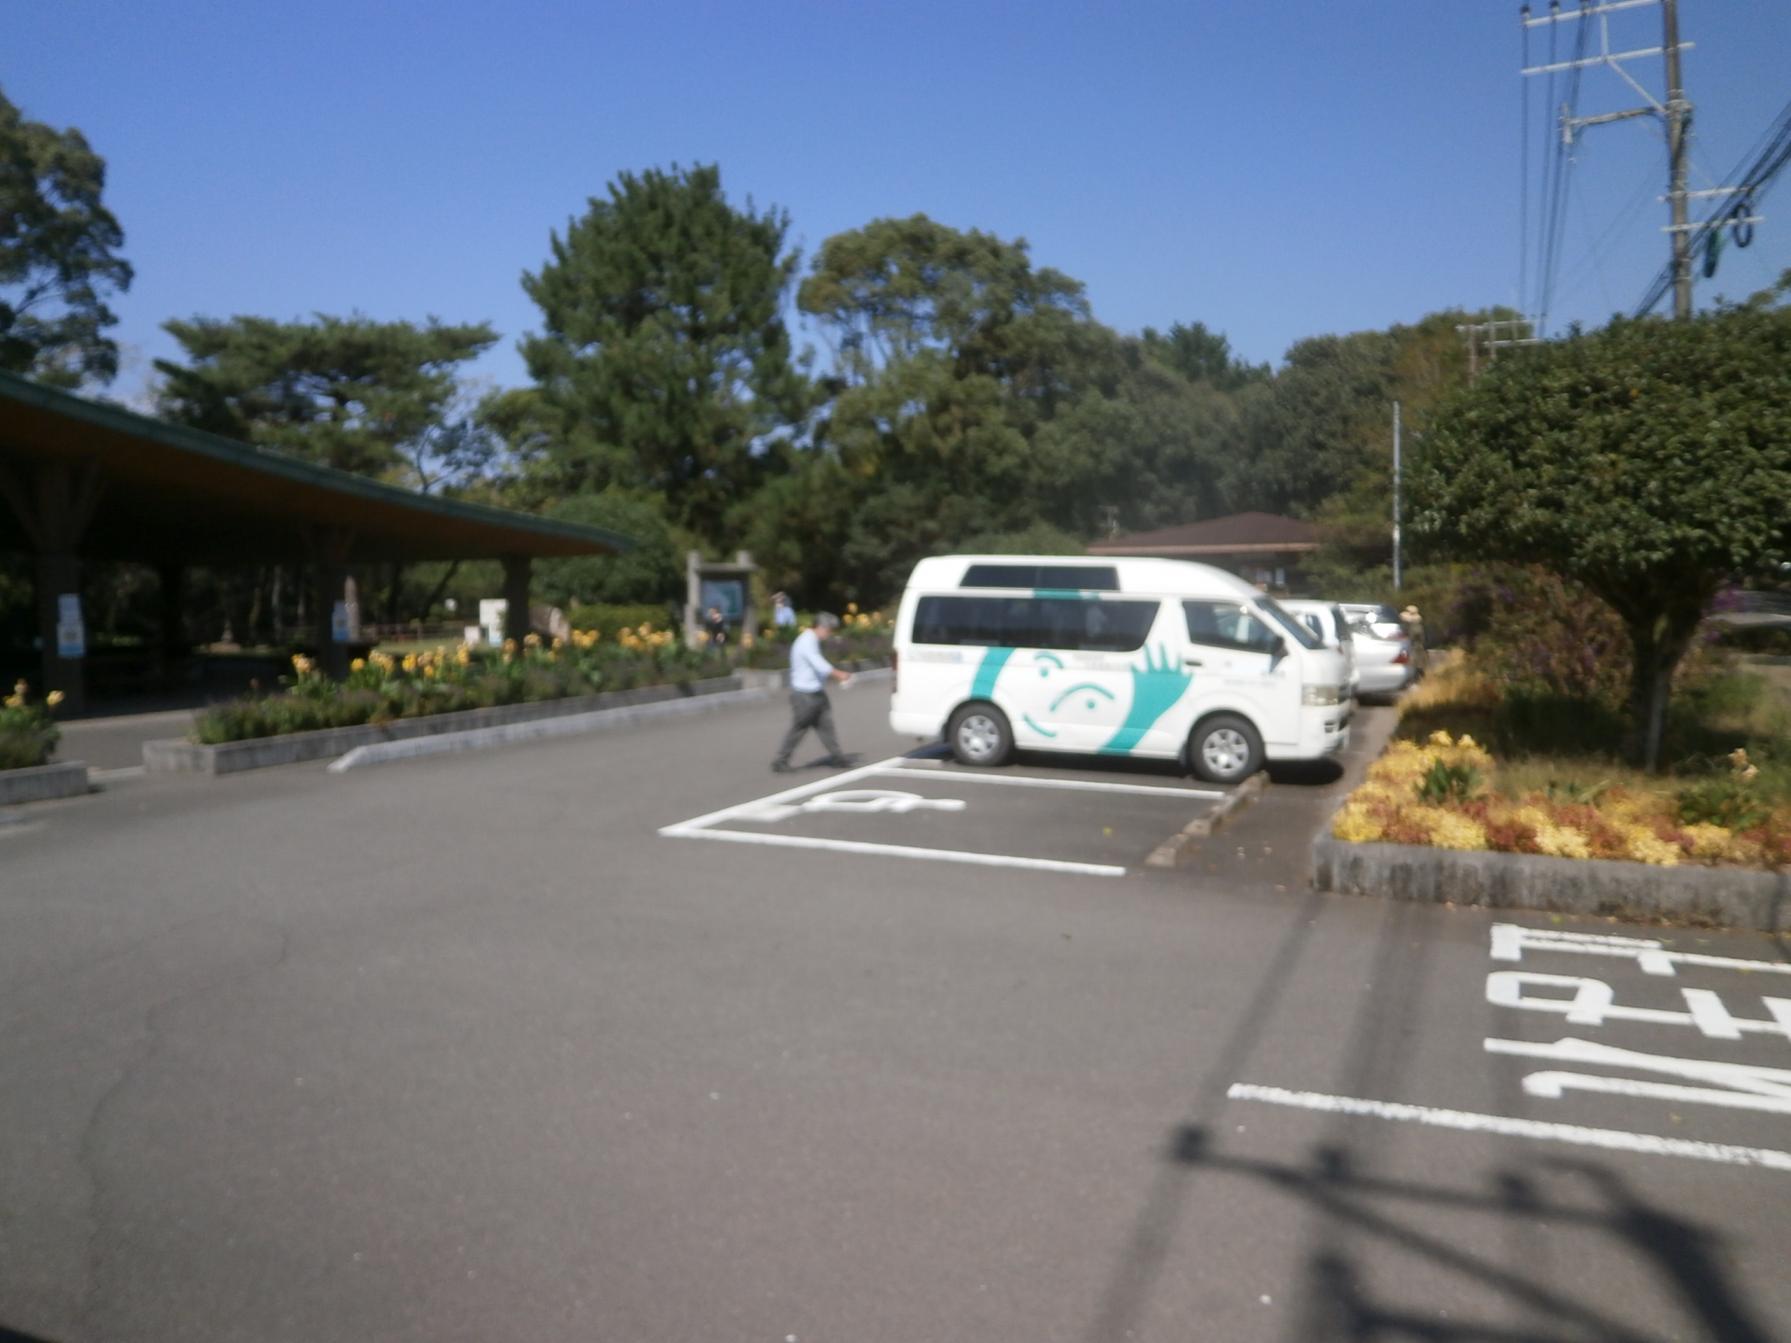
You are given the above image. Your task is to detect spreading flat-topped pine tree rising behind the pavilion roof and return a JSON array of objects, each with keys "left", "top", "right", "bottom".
[{"left": 156, "top": 313, "right": 498, "bottom": 487}]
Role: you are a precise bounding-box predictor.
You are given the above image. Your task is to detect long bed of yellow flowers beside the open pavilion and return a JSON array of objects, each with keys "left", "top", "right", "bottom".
[{"left": 192, "top": 625, "right": 727, "bottom": 745}]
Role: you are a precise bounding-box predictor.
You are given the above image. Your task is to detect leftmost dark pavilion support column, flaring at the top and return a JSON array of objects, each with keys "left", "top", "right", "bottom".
[{"left": 0, "top": 462, "right": 100, "bottom": 714}]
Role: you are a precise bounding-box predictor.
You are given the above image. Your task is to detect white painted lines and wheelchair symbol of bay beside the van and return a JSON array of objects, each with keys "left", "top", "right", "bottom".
[{"left": 659, "top": 756, "right": 1225, "bottom": 877}]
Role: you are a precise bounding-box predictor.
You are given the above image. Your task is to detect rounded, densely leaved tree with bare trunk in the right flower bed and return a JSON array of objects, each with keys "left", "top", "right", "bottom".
[{"left": 1413, "top": 299, "right": 1791, "bottom": 768}]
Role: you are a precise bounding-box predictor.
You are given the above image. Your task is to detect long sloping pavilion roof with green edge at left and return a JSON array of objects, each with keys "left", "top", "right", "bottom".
[{"left": 0, "top": 372, "right": 634, "bottom": 564}]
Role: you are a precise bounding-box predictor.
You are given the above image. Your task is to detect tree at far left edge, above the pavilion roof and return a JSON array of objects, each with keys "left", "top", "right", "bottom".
[{"left": 0, "top": 93, "right": 131, "bottom": 387}]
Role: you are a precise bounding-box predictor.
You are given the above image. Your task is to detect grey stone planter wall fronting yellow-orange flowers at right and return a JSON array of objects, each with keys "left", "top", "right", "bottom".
[{"left": 1313, "top": 834, "right": 1791, "bottom": 931}]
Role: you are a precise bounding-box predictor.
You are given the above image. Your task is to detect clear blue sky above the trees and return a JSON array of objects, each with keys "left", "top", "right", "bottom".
[{"left": 13, "top": 0, "right": 1791, "bottom": 399}]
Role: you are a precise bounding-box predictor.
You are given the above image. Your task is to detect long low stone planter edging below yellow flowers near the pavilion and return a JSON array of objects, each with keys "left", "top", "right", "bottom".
[{"left": 143, "top": 677, "right": 740, "bottom": 774}]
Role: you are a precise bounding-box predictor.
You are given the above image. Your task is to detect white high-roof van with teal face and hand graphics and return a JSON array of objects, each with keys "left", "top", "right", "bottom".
[{"left": 890, "top": 555, "right": 1350, "bottom": 783}]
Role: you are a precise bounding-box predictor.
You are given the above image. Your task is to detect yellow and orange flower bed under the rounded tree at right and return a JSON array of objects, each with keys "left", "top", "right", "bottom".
[{"left": 1331, "top": 731, "right": 1791, "bottom": 868}]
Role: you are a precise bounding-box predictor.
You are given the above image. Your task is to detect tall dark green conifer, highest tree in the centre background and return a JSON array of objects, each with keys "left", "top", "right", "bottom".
[{"left": 521, "top": 165, "right": 808, "bottom": 541}]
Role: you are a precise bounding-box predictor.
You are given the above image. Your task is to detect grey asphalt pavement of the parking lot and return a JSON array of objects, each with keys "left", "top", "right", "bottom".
[{"left": 0, "top": 686, "right": 1791, "bottom": 1343}]
